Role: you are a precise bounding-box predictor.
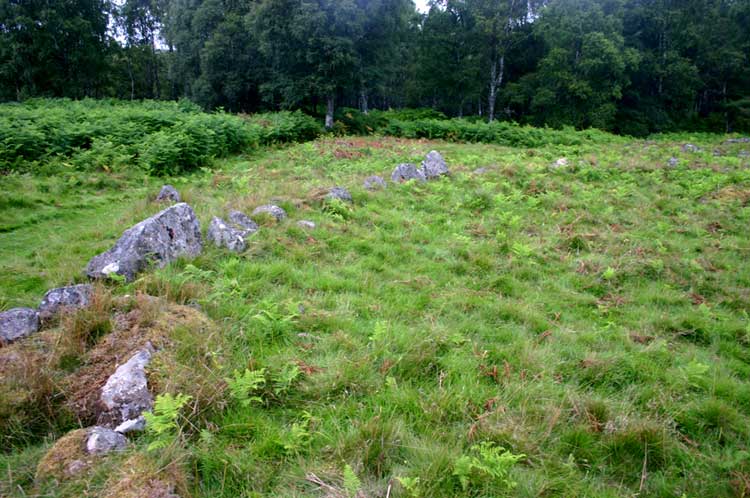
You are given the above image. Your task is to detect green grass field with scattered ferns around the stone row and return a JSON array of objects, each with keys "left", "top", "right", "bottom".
[{"left": 0, "top": 130, "right": 750, "bottom": 497}]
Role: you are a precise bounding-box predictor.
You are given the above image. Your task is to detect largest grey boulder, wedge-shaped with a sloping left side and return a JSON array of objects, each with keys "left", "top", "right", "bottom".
[{"left": 86, "top": 202, "right": 203, "bottom": 281}]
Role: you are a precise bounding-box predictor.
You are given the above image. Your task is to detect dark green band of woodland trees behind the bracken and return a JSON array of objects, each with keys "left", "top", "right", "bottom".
[{"left": 0, "top": 0, "right": 750, "bottom": 135}]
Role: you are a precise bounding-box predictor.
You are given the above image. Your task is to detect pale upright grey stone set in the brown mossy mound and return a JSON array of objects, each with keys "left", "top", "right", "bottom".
[{"left": 100, "top": 344, "right": 154, "bottom": 426}]
